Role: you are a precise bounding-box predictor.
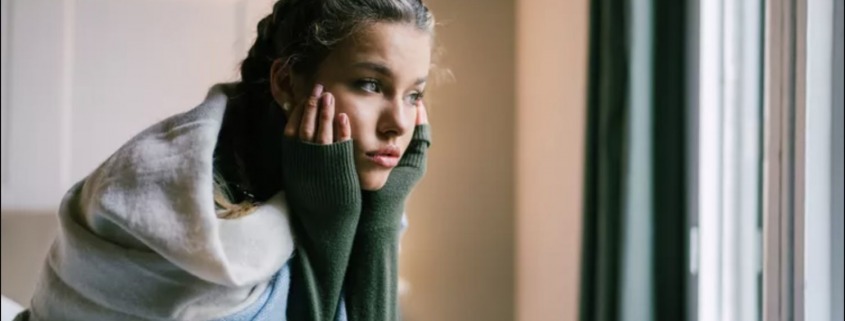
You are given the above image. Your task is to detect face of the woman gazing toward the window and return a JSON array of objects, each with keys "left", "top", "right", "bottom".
[{"left": 293, "top": 23, "right": 431, "bottom": 190}]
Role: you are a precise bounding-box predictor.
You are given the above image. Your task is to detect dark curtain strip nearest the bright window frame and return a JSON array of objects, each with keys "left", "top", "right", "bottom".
[{"left": 651, "top": 0, "right": 691, "bottom": 321}]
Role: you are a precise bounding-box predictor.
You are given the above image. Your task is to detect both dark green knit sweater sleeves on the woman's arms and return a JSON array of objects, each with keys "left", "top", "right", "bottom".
[{"left": 283, "top": 125, "right": 431, "bottom": 321}]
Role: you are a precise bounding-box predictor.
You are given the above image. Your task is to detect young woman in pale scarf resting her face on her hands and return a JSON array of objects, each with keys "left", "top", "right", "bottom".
[{"left": 18, "top": 0, "right": 434, "bottom": 320}]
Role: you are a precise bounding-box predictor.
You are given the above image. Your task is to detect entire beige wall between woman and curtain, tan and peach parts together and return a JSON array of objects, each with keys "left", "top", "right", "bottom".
[{"left": 402, "top": 0, "right": 588, "bottom": 321}]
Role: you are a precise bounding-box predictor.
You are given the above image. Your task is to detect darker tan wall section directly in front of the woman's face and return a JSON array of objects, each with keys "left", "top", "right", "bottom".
[{"left": 401, "top": 0, "right": 515, "bottom": 321}]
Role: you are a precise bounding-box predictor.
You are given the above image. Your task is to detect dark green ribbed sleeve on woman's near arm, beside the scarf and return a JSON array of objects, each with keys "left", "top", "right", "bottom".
[{"left": 283, "top": 139, "right": 361, "bottom": 320}]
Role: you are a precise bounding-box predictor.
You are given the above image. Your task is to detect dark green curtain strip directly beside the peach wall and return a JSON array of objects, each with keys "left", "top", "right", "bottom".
[{"left": 580, "top": 0, "right": 629, "bottom": 321}]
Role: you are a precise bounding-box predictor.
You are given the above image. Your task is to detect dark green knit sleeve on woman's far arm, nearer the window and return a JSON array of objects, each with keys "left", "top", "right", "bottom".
[{"left": 344, "top": 124, "right": 431, "bottom": 321}]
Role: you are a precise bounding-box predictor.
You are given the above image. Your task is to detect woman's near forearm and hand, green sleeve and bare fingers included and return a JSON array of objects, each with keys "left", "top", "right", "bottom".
[{"left": 282, "top": 85, "right": 361, "bottom": 320}]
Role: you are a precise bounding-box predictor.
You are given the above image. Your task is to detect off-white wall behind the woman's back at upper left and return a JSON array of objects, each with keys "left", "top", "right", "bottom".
[{"left": 2, "top": 0, "right": 271, "bottom": 212}]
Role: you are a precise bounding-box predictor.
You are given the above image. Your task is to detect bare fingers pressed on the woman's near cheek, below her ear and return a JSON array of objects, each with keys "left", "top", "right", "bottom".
[{"left": 285, "top": 85, "right": 352, "bottom": 145}]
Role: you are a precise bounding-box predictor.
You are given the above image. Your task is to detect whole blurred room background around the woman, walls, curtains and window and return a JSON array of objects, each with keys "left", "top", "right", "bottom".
[{"left": 0, "top": 0, "right": 845, "bottom": 321}]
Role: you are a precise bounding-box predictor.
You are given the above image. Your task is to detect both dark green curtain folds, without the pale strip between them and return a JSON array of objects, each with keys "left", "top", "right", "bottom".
[{"left": 579, "top": 0, "right": 692, "bottom": 321}]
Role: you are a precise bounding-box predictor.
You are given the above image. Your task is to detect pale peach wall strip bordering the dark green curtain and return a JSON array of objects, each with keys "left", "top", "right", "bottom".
[{"left": 516, "top": 0, "right": 589, "bottom": 321}]
